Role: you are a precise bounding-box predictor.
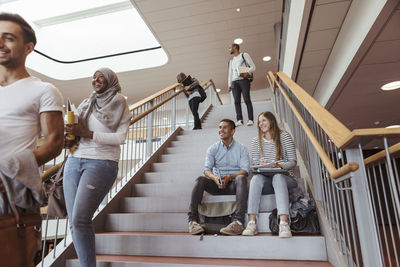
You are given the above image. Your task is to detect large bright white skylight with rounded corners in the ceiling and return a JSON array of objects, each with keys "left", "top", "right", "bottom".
[{"left": 0, "top": 0, "right": 168, "bottom": 80}]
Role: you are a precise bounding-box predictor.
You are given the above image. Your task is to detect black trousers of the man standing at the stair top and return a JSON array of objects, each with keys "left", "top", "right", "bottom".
[{"left": 232, "top": 79, "right": 254, "bottom": 121}]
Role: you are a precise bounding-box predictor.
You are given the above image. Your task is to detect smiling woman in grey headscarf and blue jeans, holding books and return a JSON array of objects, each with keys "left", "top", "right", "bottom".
[{"left": 64, "top": 68, "right": 131, "bottom": 267}]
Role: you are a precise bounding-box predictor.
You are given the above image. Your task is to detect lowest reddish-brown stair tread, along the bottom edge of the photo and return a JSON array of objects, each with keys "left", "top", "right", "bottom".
[{"left": 67, "top": 255, "right": 332, "bottom": 267}]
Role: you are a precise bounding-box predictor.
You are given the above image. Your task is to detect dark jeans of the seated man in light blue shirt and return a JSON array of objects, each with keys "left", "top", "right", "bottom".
[{"left": 188, "top": 175, "right": 247, "bottom": 223}]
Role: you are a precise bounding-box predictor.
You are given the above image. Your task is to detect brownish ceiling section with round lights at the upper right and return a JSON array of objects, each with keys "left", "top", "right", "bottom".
[{"left": 330, "top": 1, "right": 400, "bottom": 129}]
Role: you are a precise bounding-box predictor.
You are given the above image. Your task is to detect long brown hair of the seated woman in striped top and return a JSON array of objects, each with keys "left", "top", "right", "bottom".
[{"left": 257, "top": 111, "right": 283, "bottom": 160}]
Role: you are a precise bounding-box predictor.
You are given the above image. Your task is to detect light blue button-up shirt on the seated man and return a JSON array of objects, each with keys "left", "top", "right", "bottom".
[{"left": 204, "top": 139, "right": 250, "bottom": 177}]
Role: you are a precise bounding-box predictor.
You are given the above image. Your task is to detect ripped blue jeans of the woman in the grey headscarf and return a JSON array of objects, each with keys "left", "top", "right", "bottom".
[{"left": 63, "top": 157, "right": 118, "bottom": 267}]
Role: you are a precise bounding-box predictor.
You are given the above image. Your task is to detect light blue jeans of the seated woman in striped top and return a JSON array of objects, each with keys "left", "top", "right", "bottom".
[{"left": 247, "top": 173, "right": 297, "bottom": 215}]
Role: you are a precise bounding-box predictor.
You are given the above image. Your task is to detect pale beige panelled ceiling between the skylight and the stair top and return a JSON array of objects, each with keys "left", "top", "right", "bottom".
[{"left": 32, "top": 0, "right": 282, "bottom": 107}]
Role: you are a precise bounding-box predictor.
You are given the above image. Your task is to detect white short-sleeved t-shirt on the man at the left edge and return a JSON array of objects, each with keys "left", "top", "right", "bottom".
[{"left": 0, "top": 76, "right": 63, "bottom": 158}]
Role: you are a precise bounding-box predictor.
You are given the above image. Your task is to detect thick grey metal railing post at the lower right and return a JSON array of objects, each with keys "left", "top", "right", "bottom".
[{"left": 346, "top": 145, "right": 383, "bottom": 267}]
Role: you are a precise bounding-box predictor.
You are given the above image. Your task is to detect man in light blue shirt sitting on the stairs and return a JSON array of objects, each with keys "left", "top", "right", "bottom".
[{"left": 188, "top": 119, "right": 250, "bottom": 235}]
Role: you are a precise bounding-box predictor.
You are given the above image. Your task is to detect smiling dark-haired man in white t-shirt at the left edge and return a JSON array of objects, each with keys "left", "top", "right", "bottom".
[{"left": 0, "top": 13, "right": 64, "bottom": 166}]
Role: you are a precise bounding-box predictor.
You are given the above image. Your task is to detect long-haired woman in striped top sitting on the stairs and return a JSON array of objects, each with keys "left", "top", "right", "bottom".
[{"left": 243, "top": 111, "right": 297, "bottom": 237}]
